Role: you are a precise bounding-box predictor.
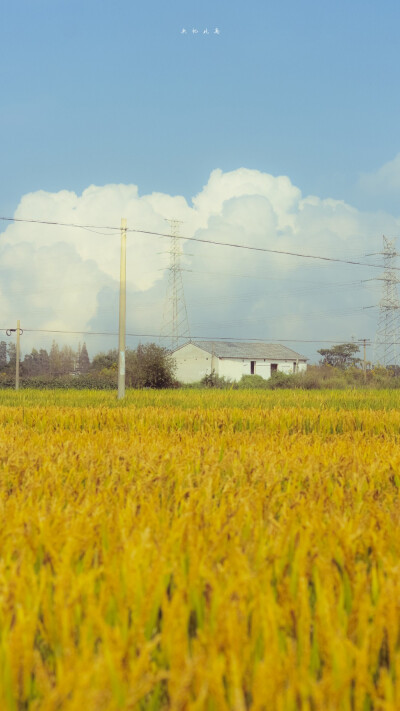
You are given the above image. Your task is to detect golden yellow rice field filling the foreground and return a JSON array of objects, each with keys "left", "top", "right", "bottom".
[{"left": 0, "top": 391, "right": 400, "bottom": 711}]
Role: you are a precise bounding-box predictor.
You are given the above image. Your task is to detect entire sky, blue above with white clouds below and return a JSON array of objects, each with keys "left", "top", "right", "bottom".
[{"left": 0, "top": 0, "right": 400, "bottom": 362}]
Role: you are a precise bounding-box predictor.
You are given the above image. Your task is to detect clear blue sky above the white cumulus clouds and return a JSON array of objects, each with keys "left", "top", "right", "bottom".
[{"left": 0, "top": 0, "right": 400, "bottom": 213}]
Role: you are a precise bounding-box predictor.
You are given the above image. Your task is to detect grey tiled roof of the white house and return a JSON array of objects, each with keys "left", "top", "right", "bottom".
[{"left": 177, "top": 341, "right": 307, "bottom": 361}]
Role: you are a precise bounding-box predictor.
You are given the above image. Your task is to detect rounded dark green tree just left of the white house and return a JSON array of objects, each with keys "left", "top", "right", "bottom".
[{"left": 126, "top": 343, "right": 175, "bottom": 388}]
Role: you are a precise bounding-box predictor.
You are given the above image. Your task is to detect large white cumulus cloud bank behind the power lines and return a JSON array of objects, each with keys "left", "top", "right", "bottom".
[{"left": 0, "top": 168, "right": 400, "bottom": 362}]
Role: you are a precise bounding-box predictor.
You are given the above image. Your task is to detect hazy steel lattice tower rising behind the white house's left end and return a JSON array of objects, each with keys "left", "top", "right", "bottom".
[{"left": 160, "top": 220, "right": 190, "bottom": 351}]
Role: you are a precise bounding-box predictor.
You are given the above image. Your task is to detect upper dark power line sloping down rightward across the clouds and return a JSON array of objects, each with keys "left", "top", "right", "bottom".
[{"left": 0, "top": 217, "right": 394, "bottom": 271}]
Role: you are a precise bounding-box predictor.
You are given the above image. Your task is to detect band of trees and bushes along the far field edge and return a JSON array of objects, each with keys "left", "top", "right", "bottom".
[{"left": 0, "top": 341, "right": 400, "bottom": 390}]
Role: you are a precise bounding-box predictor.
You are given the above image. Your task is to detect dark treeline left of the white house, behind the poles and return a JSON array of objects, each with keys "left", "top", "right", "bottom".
[{"left": 0, "top": 341, "right": 176, "bottom": 389}]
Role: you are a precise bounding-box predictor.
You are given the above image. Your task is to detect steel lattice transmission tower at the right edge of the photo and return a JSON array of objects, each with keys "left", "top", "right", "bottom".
[{"left": 375, "top": 237, "right": 400, "bottom": 366}]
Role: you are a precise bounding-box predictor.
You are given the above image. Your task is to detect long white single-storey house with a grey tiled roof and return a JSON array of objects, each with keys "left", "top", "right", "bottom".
[{"left": 173, "top": 341, "right": 307, "bottom": 383}]
